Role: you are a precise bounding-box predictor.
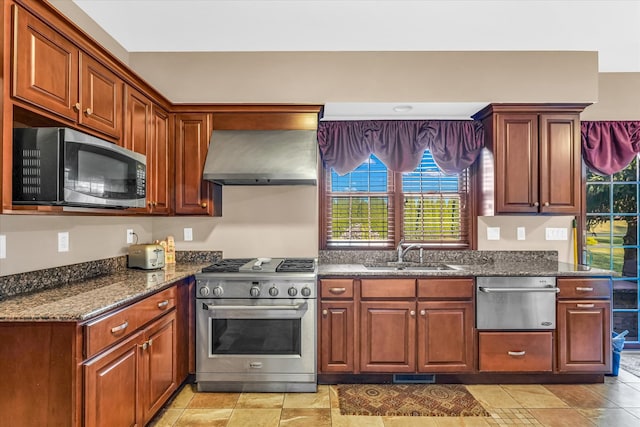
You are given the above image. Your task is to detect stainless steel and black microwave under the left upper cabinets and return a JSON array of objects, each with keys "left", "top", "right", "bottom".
[{"left": 12, "top": 128, "right": 147, "bottom": 209}]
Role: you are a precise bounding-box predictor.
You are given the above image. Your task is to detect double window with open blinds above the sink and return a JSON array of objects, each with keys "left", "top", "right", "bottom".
[{"left": 322, "top": 150, "right": 470, "bottom": 248}]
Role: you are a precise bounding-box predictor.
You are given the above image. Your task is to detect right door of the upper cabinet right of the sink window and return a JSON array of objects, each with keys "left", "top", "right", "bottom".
[{"left": 540, "top": 114, "right": 582, "bottom": 215}]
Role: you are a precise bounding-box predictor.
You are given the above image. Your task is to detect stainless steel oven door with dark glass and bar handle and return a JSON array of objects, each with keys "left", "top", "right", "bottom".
[{"left": 196, "top": 299, "right": 316, "bottom": 377}]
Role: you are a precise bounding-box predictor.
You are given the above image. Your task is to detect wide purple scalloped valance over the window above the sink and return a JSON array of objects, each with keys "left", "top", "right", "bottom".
[{"left": 318, "top": 120, "right": 484, "bottom": 175}]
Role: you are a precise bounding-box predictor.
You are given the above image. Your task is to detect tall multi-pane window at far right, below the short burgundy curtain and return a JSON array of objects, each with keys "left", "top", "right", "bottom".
[{"left": 586, "top": 157, "right": 640, "bottom": 347}]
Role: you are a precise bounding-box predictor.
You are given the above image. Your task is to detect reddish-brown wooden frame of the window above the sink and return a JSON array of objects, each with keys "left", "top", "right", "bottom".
[{"left": 318, "top": 153, "right": 480, "bottom": 250}]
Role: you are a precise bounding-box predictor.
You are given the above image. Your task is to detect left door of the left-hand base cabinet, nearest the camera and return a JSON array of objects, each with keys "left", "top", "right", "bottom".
[{"left": 83, "top": 333, "right": 142, "bottom": 427}]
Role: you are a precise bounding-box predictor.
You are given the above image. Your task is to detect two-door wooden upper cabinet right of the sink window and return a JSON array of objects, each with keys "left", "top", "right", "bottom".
[{"left": 474, "top": 104, "right": 586, "bottom": 215}]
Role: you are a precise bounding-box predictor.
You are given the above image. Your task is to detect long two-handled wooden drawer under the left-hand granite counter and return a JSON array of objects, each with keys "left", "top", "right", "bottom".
[{"left": 85, "top": 286, "right": 176, "bottom": 358}]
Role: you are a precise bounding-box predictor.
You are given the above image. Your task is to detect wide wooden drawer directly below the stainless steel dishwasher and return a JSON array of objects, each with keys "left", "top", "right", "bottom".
[{"left": 478, "top": 331, "right": 553, "bottom": 372}]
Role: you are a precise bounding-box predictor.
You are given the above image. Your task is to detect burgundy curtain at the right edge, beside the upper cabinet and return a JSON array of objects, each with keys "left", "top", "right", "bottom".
[{"left": 580, "top": 121, "right": 640, "bottom": 175}]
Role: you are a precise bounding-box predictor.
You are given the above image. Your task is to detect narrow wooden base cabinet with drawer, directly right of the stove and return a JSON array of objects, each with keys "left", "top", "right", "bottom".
[{"left": 319, "top": 279, "right": 356, "bottom": 373}]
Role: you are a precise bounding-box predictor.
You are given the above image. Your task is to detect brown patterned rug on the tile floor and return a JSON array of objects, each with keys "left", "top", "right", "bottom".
[{"left": 338, "top": 384, "right": 490, "bottom": 417}]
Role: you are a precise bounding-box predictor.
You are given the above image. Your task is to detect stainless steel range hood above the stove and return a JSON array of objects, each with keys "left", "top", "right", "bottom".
[{"left": 203, "top": 130, "right": 318, "bottom": 185}]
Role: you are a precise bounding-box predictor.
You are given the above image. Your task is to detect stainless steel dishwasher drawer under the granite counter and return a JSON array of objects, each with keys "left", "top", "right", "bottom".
[{"left": 476, "top": 276, "right": 559, "bottom": 330}]
